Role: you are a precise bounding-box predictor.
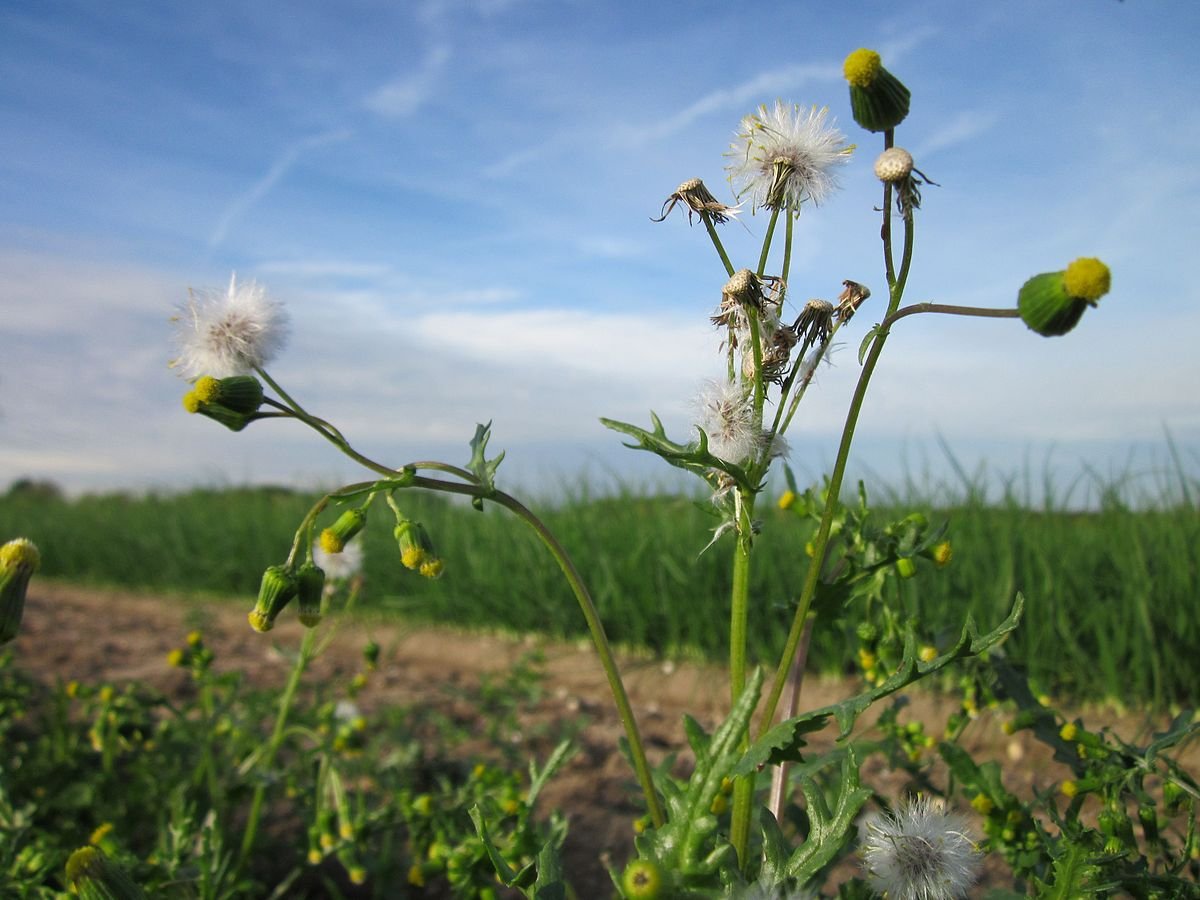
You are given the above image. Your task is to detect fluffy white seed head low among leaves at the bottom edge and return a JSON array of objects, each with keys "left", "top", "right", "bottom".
[{"left": 859, "top": 797, "right": 979, "bottom": 900}]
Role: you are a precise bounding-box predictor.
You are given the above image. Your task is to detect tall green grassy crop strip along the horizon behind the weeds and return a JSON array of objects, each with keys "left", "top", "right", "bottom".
[{"left": 0, "top": 480, "right": 1200, "bottom": 707}]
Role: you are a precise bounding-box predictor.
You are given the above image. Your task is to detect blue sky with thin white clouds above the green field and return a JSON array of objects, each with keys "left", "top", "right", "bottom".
[{"left": 0, "top": 0, "right": 1200, "bottom": 504}]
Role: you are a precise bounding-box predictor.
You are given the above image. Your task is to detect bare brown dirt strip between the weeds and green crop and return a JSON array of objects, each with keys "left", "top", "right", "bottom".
[{"left": 13, "top": 580, "right": 1200, "bottom": 898}]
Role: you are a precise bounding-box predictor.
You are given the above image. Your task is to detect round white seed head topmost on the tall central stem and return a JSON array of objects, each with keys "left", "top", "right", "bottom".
[{"left": 726, "top": 101, "right": 854, "bottom": 212}]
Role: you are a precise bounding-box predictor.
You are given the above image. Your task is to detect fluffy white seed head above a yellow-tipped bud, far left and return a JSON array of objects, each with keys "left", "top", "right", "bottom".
[{"left": 170, "top": 275, "right": 288, "bottom": 378}]
